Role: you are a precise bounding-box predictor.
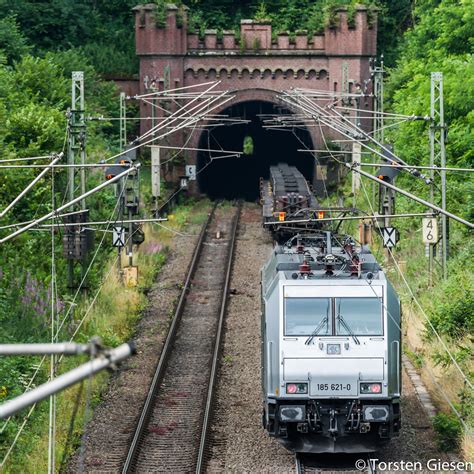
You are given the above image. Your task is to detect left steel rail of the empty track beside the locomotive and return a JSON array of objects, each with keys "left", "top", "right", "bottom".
[{"left": 122, "top": 203, "right": 217, "bottom": 474}]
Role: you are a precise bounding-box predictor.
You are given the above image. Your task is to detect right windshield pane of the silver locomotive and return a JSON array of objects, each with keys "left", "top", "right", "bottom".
[{"left": 336, "top": 298, "right": 383, "bottom": 336}]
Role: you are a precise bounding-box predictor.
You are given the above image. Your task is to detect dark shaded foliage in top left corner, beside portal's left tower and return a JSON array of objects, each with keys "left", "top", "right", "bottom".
[{"left": 0, "top": 0, "right": 139, "bottom": 75}]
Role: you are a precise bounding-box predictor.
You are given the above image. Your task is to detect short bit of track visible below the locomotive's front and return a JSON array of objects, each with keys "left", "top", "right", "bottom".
[{"left": 295, "top": 453, "right": 376, "bottom": 474}]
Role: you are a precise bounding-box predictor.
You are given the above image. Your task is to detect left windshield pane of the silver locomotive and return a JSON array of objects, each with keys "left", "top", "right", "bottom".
[{"left": 285, "top": 298, "right": 332, "bottom": 336}]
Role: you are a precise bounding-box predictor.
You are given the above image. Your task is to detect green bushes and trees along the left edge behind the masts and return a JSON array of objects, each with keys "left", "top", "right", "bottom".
[{"left": 0, "top": 25, "right": 125, "bottom": 458}]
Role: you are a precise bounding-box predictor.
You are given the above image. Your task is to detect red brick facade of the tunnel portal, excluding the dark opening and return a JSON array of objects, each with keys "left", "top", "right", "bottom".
[{"left": 134, "top": 4, "right": 377, "bottom": 194}]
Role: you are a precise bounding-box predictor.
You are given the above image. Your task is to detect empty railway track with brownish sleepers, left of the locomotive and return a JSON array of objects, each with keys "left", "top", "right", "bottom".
[{"left": 122, "top": 204, "right": 241, "bottom": 473}]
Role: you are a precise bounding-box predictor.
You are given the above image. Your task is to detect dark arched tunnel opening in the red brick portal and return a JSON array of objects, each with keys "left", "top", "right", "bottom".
[{"left": 197, "top": 101, "right": 314, "bottom": 201}]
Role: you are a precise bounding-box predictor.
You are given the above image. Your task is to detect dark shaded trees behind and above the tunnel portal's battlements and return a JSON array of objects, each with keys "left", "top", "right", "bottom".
[{"left": 0, "top": 0, "right": 412, "bottom": 76}]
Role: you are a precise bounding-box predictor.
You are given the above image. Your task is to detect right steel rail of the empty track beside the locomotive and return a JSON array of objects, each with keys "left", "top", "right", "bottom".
[{"left": 196, "top": 201, "right": 242, "bottom": 474}]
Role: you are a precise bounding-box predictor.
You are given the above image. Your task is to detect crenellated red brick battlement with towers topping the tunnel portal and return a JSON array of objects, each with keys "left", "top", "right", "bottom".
[{"left": 134, "top": 4, "right": 377, "bottom": 56}]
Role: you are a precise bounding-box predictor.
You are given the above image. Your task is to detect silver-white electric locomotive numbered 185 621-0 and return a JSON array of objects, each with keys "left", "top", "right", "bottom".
[{"left": 262, "top": 231, "right": 401, "bottom": 453}]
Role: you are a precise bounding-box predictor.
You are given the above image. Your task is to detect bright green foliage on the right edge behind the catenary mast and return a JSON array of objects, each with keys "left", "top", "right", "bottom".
[{"left": 387, "top": 0, "right": 474, "bottom": 344}]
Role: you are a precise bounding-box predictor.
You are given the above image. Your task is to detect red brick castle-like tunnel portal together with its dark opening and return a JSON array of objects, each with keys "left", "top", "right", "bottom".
[{"left": 134, "top": 4, "right": 377, "bottom": 199}]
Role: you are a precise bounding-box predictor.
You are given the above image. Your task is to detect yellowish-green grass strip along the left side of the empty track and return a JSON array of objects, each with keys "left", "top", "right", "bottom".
[{"left": 0, "top": 196, "right": 209, "bottom": 473}]
